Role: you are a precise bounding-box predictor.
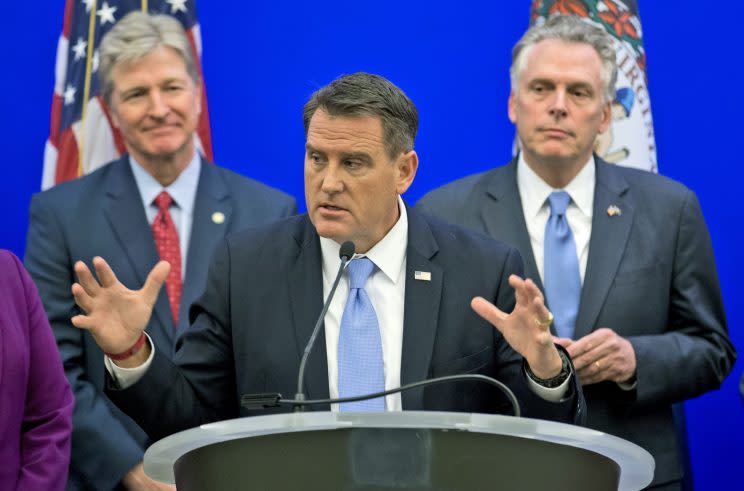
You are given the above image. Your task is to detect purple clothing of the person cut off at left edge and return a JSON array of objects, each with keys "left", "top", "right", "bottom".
[{"left": 0, "top": 250, "right": 74, "bottom": 491}]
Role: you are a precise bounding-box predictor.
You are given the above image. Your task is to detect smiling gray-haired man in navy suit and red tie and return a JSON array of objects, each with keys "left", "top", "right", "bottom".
[{"left": 25, "top": 12, "right": 296, "bottom": 489}]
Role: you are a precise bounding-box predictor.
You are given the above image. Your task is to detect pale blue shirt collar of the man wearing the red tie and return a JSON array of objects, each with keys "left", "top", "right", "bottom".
[{"left": 129, "top": 152, "right": 201, "bottom": 215}]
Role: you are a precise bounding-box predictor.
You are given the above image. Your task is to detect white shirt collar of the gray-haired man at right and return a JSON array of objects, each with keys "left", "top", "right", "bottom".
[{"left": 517, "top": 152, "right": 597, "bottom": 218}]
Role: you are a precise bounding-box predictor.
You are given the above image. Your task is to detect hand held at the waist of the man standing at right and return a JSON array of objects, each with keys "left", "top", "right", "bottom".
[{"left": 554, "top": 327, "right": 636, "bottom": 385}]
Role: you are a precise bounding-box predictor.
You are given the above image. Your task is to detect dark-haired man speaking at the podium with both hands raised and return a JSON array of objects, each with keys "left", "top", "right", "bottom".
[{"left": 67, "top": 73, "right": 583, "bottom": 446}]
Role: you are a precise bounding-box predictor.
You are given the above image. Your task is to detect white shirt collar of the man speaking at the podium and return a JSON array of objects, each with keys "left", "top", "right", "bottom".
[{"left": 320, "top": 196, "right": 408, "bottom": 283}]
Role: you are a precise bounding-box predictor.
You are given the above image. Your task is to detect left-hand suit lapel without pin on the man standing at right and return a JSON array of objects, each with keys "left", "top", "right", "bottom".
[{"left": 478, "top": 159, "right": 544, "bottom": 290}]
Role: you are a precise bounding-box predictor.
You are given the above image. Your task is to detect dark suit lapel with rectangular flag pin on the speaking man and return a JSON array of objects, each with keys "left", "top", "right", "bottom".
[{"left": 400, "top": 208, "right": 444, "bottom": 410}]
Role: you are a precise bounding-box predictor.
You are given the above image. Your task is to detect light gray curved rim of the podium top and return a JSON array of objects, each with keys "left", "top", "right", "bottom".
[{"left": 144, "top": 411, "right": 654, "bottom": 490}]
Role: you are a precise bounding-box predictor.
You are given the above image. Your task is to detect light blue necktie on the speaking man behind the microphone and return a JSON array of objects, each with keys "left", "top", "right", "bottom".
[{"left": 338, "top": 257, "right": 385, "bottom": 411}]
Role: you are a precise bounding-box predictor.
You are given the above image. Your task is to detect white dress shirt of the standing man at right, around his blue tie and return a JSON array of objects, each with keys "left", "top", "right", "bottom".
[{"left": 517, "top": 153, "right": 597, "bottom": 285}]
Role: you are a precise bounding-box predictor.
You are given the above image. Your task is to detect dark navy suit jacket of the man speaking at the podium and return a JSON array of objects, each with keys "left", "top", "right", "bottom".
[{"left": 107, "top": 210, "right": 584, "bottom": 438}]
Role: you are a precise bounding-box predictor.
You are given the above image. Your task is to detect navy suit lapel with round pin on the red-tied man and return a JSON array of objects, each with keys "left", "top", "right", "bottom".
[{"left": 178, "top": 163, "right": 233, "bottom": 331}]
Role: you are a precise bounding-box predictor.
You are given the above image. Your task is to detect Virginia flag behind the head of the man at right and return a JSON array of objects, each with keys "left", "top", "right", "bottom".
[{"left": 530, "top": 0, "right": 658, "bottom": 172}]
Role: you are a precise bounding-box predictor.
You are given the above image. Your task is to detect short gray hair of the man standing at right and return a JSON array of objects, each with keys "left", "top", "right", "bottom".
[{"left": 509, "top": 15, "right": 617, "bottom": 101}]
